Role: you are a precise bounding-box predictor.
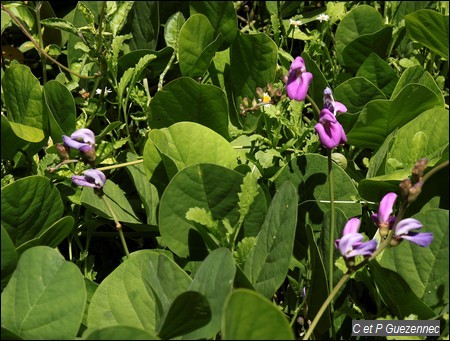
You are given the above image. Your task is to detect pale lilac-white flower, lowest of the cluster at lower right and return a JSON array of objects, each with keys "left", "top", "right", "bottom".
[{"left": 334, "top": 218, "right": 377, "bottom": 258}]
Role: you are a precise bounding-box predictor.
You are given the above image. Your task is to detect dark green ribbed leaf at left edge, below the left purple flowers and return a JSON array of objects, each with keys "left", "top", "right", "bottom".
[{"left": 1, "top": 176, "right": 64, "bottom": 247}]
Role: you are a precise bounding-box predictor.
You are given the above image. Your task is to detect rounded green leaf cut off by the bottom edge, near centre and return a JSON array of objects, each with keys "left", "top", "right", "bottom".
[{"left": 222, "top": 289, "right": 294, "bottom": 340}]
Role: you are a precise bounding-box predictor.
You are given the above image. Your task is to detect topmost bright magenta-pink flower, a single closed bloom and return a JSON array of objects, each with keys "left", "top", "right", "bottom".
[{"left": 286, "top": 57, "right": 313, "bottom": 101}]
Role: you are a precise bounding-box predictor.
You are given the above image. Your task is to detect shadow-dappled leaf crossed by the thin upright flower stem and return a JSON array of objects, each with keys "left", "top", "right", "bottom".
[{"left": 275, "top": 154, "right": 361, "bottom": 231}]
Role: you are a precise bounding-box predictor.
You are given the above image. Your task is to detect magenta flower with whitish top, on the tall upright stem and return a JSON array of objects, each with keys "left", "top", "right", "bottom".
[{"left": 314, "top": 88, "right": 347, "bottom": 149}]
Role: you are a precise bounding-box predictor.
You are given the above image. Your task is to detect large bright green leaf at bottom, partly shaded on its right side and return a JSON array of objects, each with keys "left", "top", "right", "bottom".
[{"left": 87, "top": 250, "right": 191, "bottom": 334}]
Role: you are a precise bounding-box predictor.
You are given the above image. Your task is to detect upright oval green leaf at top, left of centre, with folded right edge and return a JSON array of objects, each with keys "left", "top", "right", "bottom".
[{"left": 178, "top": 14, "right": 222, "bottom": 77}]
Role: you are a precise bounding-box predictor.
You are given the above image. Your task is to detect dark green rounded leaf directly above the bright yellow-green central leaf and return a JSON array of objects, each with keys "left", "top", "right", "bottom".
[{"left": 149, "top": 77, "right": 229, "bottom": 139}]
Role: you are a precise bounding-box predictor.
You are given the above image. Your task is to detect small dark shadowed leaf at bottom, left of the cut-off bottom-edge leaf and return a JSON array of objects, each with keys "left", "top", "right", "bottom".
[{"left": 157, "top": 291, "right": 211, "bottom": 340}]
